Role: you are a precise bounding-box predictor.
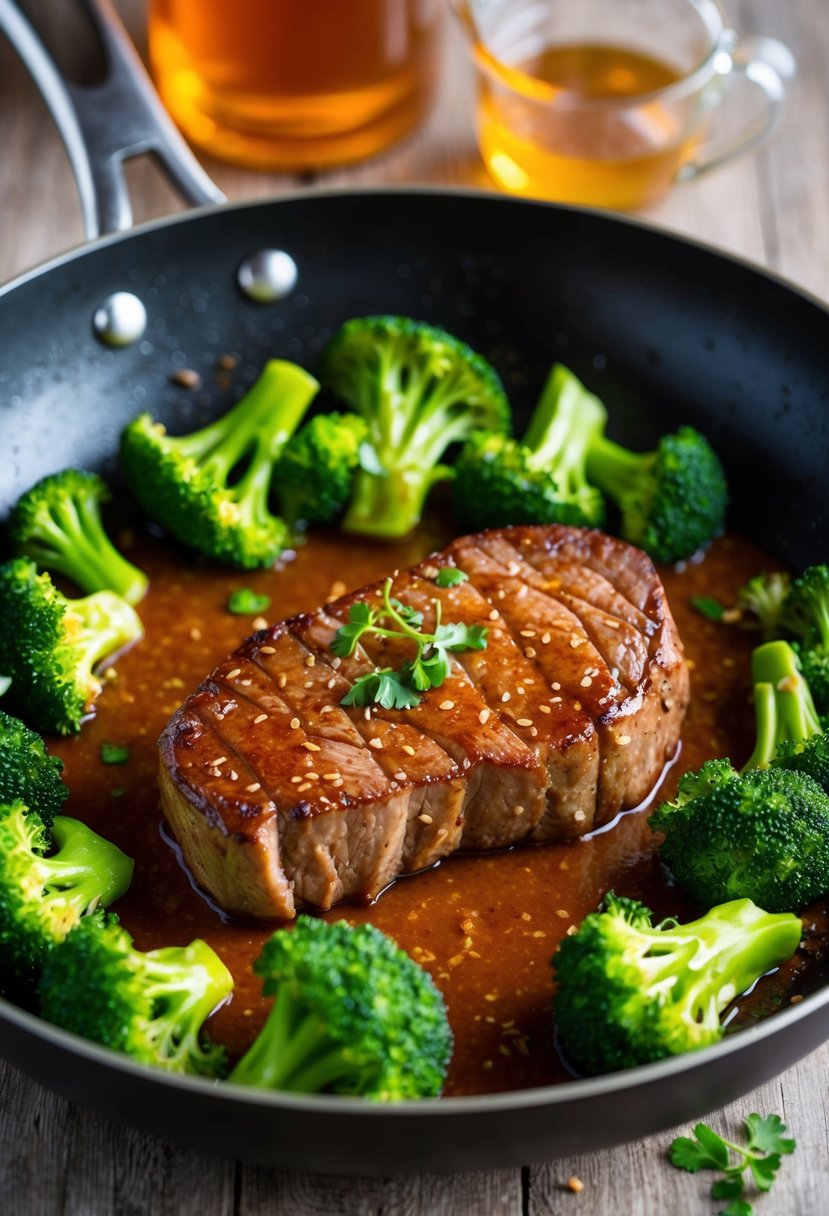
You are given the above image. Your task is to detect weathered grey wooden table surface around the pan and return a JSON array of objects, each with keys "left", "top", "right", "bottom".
[{"left": 0, "top": 0, "right": 829, "bottom": 1216}]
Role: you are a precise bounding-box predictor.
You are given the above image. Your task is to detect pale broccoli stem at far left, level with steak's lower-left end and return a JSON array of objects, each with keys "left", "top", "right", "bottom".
[{"left": 43, "top": 815, "right": 132, "bottom": 916}]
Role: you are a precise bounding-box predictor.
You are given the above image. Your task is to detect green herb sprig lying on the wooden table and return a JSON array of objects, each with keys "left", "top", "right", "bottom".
[{"left": 670, "top": 1115, "right": 795, "bottom": 1216}]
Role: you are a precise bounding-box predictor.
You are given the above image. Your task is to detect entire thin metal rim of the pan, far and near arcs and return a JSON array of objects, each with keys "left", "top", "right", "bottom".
[{"left": 0, "top": 185, "right": 829, "bottom": 1119}]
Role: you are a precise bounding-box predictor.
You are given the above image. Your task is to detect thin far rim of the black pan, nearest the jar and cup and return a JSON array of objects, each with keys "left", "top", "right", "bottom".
[{"left": 0, "top": 184, "right": 829, "bottom": 314}]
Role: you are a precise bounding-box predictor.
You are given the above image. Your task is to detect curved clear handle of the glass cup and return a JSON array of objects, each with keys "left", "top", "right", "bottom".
[{"left": 676, "top": 30, "right": 797, "bottom": 181}]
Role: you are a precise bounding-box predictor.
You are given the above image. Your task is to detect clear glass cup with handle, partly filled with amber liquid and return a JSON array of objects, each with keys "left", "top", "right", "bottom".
[{"left": 453, "top": 0, "right": 795, "bottom": 209}]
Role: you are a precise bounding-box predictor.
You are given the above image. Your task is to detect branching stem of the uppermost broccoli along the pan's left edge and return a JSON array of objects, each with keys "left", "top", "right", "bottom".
[{"left": 27, "top": 495, "right": 148, "bottom": 604}]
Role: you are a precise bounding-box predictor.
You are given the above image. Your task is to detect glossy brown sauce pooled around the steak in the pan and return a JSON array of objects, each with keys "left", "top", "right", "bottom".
[{"left": 46, "top": 525, "right": 827, "bottom": 1094}]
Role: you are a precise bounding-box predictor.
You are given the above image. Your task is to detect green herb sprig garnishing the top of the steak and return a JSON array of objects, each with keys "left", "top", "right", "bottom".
[{"left": 331, "top": 579, "right": 486, "bottom": 709}]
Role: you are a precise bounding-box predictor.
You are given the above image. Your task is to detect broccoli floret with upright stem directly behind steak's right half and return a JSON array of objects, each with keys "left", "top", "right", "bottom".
[{"left": 452, "top": 364, "right": 608, "bottom": 528}]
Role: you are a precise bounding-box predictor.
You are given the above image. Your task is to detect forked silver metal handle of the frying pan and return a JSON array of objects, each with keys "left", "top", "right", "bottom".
[{"left": 0, "top": 0, "right": 225, "bottom": 240}]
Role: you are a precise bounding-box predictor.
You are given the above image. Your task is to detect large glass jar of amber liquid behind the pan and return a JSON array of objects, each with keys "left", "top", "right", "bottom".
[{"left": 150, "top": 0, "right": 441, "bottom": 169}]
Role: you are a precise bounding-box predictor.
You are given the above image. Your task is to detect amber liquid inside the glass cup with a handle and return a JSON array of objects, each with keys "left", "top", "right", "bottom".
[{"left": 478, "top": 44, "right": 700, "bottom": 208}]
